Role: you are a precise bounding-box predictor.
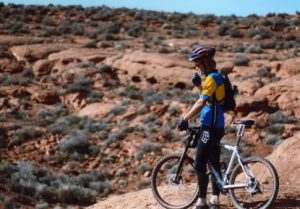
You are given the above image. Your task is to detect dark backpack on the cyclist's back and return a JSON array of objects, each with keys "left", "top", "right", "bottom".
[{"left": 220, "top": 73, "right": 238, "bottom": 112}]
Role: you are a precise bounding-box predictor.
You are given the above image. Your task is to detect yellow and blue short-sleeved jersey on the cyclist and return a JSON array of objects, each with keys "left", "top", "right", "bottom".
[{"left": 200, "top": 72, "right": 225, "bottom": 128}]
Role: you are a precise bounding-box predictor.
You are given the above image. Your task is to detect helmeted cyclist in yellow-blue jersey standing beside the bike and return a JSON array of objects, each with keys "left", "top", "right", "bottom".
[{"left": 178, "top": 46, "right": 225, "bottom": 209}]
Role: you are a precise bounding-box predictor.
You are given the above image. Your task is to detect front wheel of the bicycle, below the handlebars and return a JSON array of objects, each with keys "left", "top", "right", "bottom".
[{"left": 151, "top": 153, "right": 198, "bottom": 209}]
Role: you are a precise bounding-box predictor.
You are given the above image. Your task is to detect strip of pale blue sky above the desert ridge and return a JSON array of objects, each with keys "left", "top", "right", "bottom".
[{"left": 3, "top": 0, "right": 300, "bottom": 16}]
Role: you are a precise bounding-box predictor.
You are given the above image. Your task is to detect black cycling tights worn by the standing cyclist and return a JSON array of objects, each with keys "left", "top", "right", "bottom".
[{"left": 195, "top": 129, "right": 224, "bottom": 198}]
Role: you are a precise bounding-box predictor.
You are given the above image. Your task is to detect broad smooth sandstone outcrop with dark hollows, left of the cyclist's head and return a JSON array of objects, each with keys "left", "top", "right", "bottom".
[{"left": 106, "top": 51, "right": 193, "bottom": 88}]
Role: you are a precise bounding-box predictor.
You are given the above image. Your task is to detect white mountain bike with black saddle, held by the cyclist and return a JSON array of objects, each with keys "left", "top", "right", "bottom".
[{"left": 151, "top": 120, "right": 279, "bottom": 209}]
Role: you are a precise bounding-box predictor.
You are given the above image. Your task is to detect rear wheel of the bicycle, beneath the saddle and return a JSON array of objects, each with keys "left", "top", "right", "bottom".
[{"left": 229, "top": 157, "right": 279, "bottom": 209}]
